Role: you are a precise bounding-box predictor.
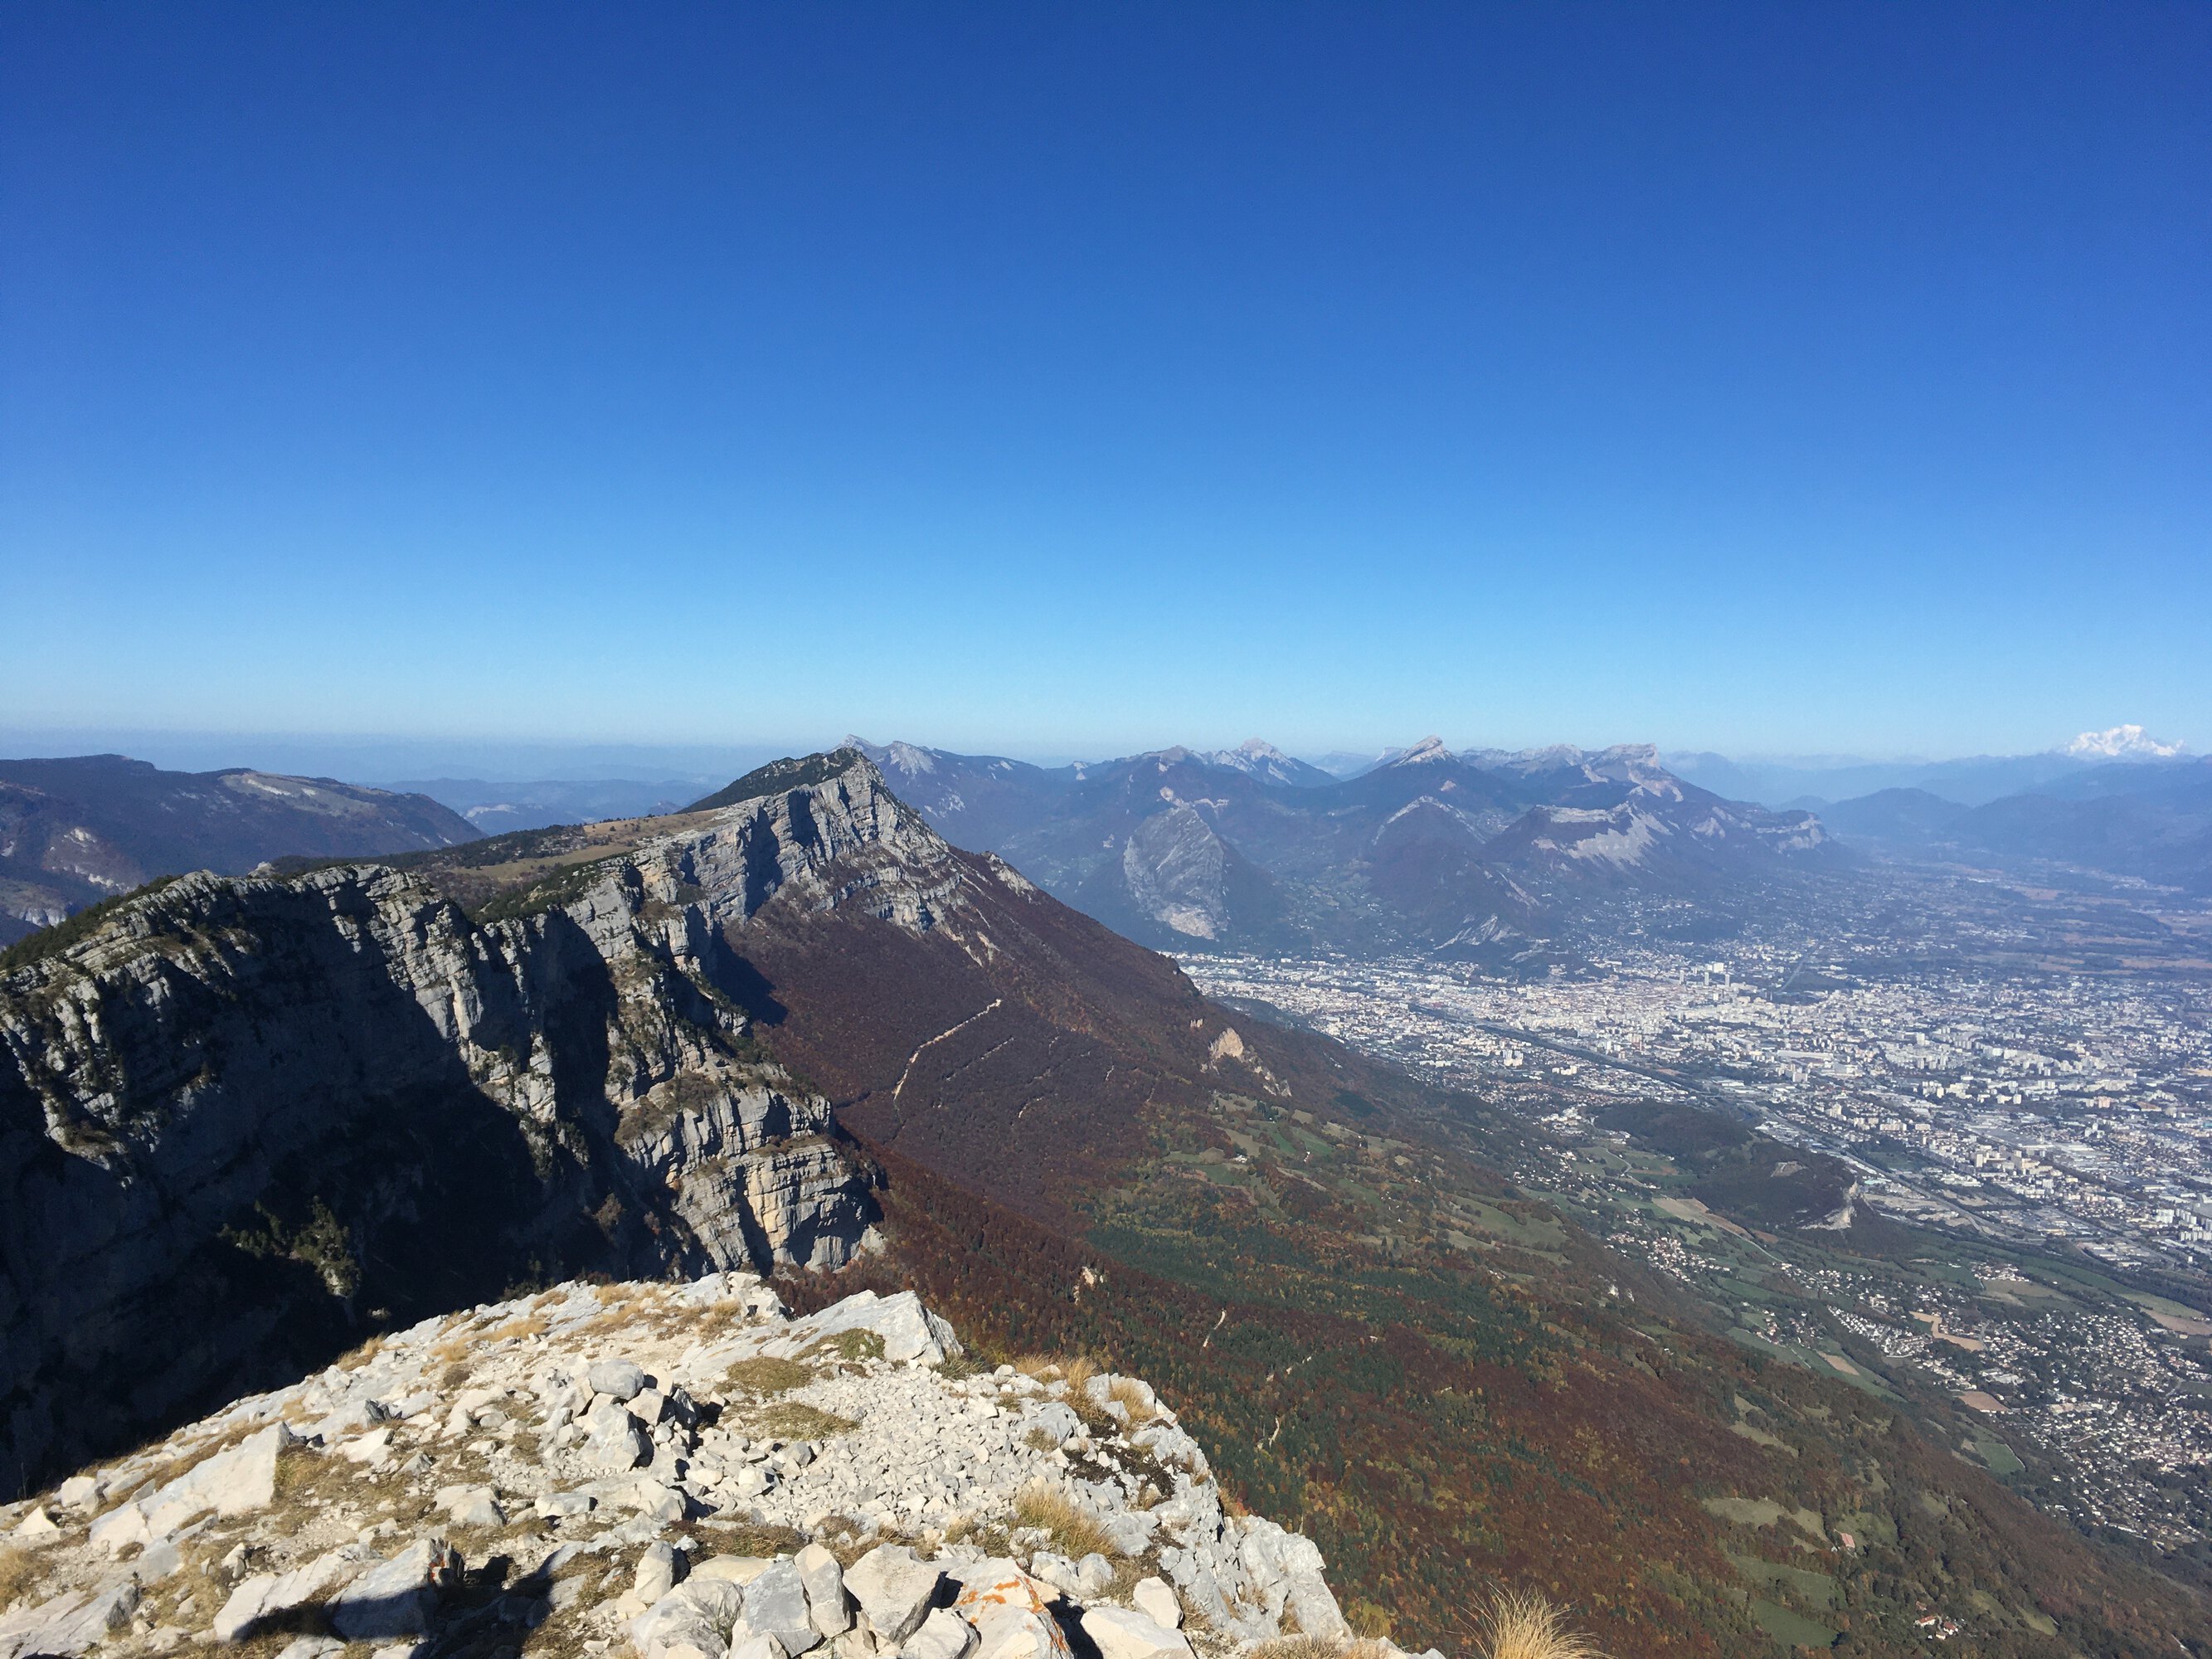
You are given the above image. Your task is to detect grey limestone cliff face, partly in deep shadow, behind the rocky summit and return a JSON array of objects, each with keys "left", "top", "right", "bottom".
[{"left": 0, "top": 761, "right": 960, "bottom": 1491}]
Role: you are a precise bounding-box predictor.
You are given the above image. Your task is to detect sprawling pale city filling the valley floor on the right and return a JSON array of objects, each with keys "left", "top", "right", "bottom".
[{"left": 1181, "top": 869, "right": 2212, "bottom": 1570}]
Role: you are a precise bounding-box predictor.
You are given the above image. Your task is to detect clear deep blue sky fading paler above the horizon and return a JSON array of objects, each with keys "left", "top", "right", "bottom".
[{"left": 0, "top": 2, "right": 2212, "bottom": 759}]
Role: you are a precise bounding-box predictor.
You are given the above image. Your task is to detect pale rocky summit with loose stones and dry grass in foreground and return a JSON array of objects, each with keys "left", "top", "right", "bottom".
[{"left": 0, "top": 1272, "right": 1396, "bottom": 1659}]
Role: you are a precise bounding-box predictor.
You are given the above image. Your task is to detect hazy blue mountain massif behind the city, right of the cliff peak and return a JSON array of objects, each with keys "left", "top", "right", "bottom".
[{"left": 847, "top": 737, "right": 1838, "bottom": 962}]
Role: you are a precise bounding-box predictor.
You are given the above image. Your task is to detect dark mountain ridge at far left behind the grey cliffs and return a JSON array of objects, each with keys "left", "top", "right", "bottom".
[{"left": 0, "top": 754, "right": 480, "bottom": 945}]
